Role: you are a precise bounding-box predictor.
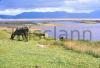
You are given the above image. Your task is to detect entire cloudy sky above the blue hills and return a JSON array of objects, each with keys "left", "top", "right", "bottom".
[{"left": 0, "top": 0, "right": 100, "bottom": 15}]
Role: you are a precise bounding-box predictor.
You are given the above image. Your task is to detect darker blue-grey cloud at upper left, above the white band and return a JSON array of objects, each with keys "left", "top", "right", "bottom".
[{"left": 0, "top": 0, "right": 64, "bottom": 9}]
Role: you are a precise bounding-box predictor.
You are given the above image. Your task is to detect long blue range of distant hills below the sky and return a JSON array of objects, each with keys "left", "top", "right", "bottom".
[{"left": 0, "top": 11, "right": 100, "bottom": 19}]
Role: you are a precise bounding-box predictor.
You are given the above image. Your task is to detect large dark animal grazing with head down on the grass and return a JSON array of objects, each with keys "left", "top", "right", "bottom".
[{"left": 10, "top": 27, "right": 29, "bottom": 41}]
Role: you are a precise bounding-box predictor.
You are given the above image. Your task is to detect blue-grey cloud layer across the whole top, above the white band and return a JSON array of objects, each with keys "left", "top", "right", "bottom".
[{"left": 0, "top": 0, "right": 100, "bottom": 9}]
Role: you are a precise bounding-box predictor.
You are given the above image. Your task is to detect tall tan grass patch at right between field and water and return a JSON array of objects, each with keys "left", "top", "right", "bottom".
[{"left": 63, "top": 40, "right": 100, "bottom": 58}]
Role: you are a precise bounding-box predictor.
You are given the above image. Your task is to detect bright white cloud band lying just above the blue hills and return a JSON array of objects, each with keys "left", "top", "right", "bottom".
[{"left": 0, "top": 8, "right": 94, "bottom": 15}]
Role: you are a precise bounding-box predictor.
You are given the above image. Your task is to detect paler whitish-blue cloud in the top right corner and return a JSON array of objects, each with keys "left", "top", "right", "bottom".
[{"left": 63, "top": 0, "right": 100, "bottom": 10}]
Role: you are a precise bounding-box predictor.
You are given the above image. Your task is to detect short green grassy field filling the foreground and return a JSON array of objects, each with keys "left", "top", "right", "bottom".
[{"left": 0, "top": 30, "right": 100, "bottom": 68}]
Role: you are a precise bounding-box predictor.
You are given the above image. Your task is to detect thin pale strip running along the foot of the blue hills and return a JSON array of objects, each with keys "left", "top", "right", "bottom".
[{"left": 0, "top": 18, "right": 100, "bottom": 21}]
